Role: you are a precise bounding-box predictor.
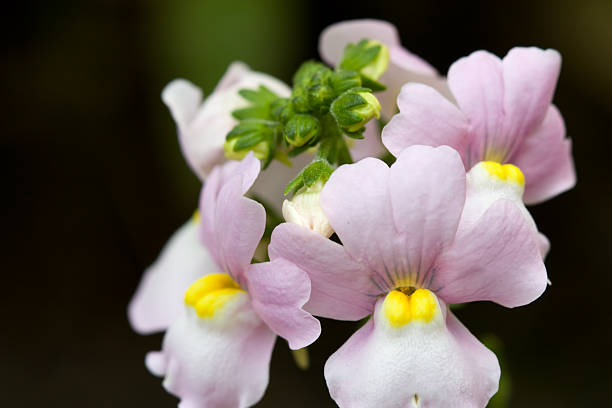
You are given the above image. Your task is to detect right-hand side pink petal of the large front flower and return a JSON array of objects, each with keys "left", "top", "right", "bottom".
[{"left": 430, "top": 199, "right": 547, "bottom": 307}]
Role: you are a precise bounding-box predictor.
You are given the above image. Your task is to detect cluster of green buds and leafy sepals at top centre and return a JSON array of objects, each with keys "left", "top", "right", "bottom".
[{"left": 225, "top": 40, "right": 389, "bottom": 167}]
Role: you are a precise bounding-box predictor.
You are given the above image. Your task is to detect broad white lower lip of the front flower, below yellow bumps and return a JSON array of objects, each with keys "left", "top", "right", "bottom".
[{"left": 325, "top": 299, "right": 500, "bottom": 408}]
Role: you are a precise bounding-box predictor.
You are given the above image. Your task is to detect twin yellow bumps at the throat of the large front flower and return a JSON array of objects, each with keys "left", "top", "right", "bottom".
[{"left": 382, "top": 289, "right": 438, "bottom": 328}]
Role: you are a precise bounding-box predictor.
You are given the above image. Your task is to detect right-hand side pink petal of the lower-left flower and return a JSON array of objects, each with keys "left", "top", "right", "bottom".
[{"left": 245, "top": 258, "right": 321, "bottom": 350}]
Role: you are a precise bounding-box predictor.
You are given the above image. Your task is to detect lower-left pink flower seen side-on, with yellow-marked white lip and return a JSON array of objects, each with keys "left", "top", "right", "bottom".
[{"left": 146, "top": 153, "right": 321, "bottom": 408}]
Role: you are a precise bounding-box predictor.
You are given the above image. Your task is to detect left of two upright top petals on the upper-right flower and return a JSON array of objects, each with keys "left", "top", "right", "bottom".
[{"left": 448, "top": 51, "right": 509, "bottom": 165}]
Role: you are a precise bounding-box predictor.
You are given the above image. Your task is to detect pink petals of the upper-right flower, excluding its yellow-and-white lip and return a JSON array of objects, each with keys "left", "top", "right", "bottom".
[{"left": 383, "top": 48, "right": 576, "bottom": 204}]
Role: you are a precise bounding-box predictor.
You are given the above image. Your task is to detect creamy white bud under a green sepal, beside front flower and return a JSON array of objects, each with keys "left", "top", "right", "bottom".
[{"left": 283, "top": 180, "right": 334, "bottom": 238}]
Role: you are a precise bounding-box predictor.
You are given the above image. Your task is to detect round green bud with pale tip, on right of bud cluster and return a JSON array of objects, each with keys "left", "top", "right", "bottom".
[{"left": 330, "top": 88, "right": 380, "bottom": 133}]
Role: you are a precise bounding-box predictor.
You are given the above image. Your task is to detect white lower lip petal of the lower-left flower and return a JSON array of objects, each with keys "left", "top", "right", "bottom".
[{"left": 147, "top": 292, "right": 276, "bottom": 407}]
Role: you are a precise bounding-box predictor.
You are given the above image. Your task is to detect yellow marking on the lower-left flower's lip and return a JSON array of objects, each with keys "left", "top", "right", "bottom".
[{"left": 185, "top": 273, "right": 244, "bottom": 317}]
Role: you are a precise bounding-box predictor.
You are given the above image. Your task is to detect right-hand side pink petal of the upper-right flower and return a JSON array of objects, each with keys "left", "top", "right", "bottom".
[{"left": 511, "top": 105, "right": 576, "bottom": 204}]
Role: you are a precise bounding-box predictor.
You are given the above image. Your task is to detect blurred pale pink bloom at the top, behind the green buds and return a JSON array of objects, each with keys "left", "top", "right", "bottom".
[{"left": 319, "top": 19, "right": 447, "bottom": 120}]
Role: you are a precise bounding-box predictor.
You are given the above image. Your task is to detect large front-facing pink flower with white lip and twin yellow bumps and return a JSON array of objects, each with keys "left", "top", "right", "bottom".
[{"left": 269, "top": 146, "right": 547, "bottom": 408}]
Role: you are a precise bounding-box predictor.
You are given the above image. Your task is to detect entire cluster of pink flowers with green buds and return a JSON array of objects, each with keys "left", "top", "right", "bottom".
[{"left": 128, "top": 20, "right": 575, "bottom": 408}]
